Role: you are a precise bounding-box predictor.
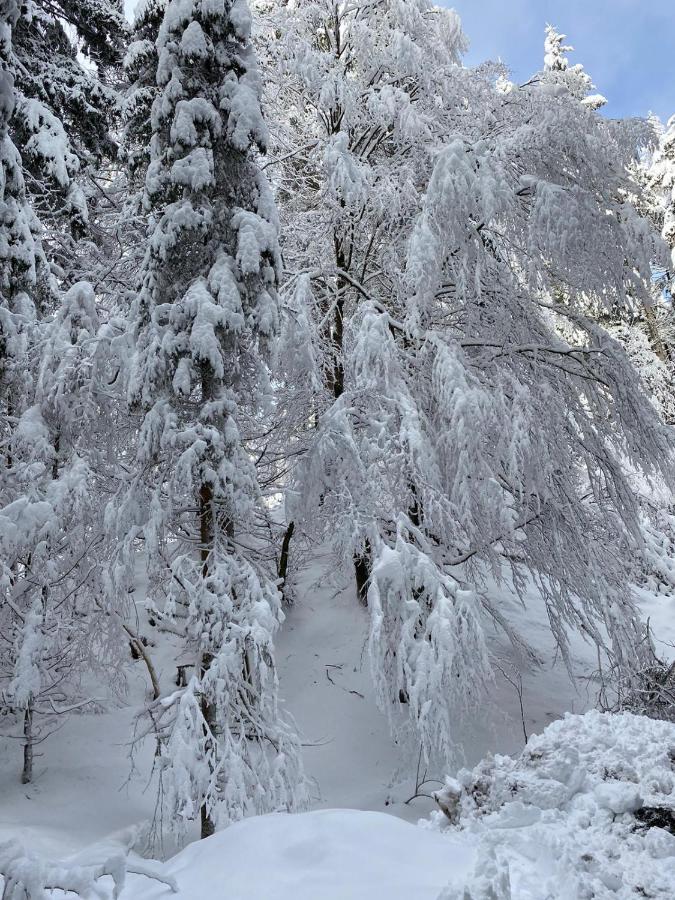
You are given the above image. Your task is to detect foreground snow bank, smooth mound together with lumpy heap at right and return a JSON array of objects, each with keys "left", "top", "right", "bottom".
[{"left": 5, "top": 712, "right": 675, "bottom": 900}]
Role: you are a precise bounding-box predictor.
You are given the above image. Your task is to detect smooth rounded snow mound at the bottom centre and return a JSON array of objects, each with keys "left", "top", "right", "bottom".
[{"left": 127, "top": 810, "right": 474, "bottom": 900}]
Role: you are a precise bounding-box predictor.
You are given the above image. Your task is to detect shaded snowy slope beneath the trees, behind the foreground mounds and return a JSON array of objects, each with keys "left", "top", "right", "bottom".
[{"left": 0, "top": 556, "right": 608, "bottom": 856}]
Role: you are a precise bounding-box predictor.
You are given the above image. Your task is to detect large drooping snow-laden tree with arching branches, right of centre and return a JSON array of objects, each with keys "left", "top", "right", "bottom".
[{"left": 272, "top": 15, "right": 671, "bottom": 752}]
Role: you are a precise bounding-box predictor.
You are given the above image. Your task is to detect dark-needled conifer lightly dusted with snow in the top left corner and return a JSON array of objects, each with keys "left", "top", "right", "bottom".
[{"left": 10, "top": 0, "right": 126, "bottom": 286}]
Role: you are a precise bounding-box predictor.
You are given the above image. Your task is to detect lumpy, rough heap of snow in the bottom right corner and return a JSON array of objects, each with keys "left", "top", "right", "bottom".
[{"left": 432, "top": 712, "right": 675, "bottom": 900}]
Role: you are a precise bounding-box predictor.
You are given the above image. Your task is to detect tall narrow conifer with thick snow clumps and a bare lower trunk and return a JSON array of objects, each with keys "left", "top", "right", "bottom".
[{"left": 110, "top": 0, "right": 301, "bottom": 836}]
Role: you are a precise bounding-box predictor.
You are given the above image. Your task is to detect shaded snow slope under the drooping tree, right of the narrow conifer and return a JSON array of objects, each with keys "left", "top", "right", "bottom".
[{"left": 277, "top": 558, "right": 597, "bottom": 821}]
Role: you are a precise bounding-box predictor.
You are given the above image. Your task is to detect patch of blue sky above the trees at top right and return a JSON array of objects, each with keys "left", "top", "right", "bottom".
[{"left": 446, "top": 0, "right": 675, "bottom": 120}]
